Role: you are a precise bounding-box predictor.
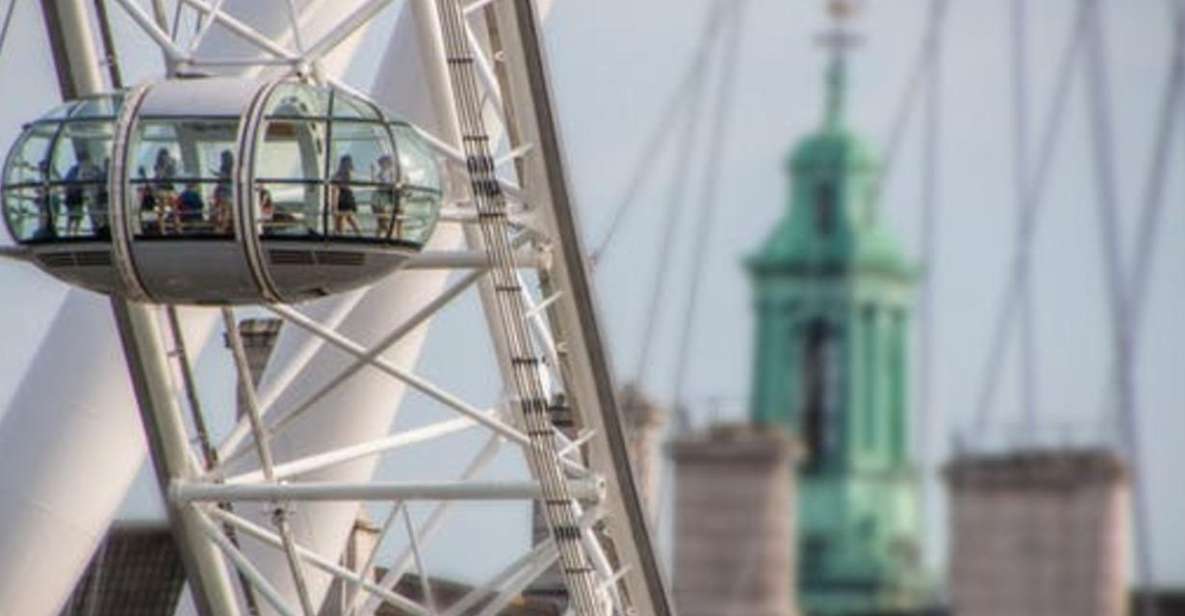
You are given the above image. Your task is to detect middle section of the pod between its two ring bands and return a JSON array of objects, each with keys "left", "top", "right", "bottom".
[{"left": 126, "top": 79, "right": 262, "bottom": 303}]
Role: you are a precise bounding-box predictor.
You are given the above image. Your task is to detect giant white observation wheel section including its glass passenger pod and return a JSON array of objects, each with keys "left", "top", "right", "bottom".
[{"left": 0, "top": 0, "right": 671, "bottom": 616}]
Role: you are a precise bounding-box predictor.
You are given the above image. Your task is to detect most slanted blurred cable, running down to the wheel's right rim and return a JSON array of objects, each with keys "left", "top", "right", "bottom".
[{"left": 589, "top": 0, "right": 726, "bottom": 263}]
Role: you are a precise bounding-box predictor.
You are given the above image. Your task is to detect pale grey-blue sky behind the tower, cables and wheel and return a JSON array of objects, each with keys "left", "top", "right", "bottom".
[{"left": 0, "top": 0, "right": 1185, "bottom": 584}]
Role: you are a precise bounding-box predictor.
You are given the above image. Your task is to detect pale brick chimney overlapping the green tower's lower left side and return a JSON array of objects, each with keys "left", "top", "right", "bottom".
[{"left": 670, "top": 425, "right": 799, "bottom": 616}]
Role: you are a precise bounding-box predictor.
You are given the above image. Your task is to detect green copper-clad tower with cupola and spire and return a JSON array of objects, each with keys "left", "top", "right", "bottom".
[{"left": 747, "top": 5, "right": 923, "bottom": 615}]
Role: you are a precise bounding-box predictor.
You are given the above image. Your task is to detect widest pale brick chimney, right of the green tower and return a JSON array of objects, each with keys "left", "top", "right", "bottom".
[{"left": 946, "top": 449, "right": 1128, "bottom": 616}]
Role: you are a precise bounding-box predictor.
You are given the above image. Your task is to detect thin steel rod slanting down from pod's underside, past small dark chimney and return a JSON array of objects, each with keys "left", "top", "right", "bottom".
[{"left": 217, "top": 308, "right": 316, "bottom": 616}]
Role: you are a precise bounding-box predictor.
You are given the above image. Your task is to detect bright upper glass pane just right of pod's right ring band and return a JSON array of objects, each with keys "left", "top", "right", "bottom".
[{"left": 255, "top": 120, "right": 325, "bottom": 180}]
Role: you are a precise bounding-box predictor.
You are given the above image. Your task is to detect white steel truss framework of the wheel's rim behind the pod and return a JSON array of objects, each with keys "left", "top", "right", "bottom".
[{"left": 37, "top": 0, "right": 671, "bottom": 616}]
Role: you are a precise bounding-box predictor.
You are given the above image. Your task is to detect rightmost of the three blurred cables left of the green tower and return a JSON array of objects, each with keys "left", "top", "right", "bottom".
[{"left": 672, "top": 0, "right": 749, "bottom": 430}]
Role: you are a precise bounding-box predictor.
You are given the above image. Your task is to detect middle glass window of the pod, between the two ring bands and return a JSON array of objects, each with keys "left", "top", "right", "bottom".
[{"left": 128, "top": 120, "right": 238, "bottom": 237}]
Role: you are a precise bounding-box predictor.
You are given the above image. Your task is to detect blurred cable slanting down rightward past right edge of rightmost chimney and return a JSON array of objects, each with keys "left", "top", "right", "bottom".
[{"left": 1083, "top": 0, "right": 1158, "bottom": 616}]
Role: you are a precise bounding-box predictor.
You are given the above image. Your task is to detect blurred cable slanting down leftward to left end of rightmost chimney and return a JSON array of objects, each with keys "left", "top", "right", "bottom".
[{"left": 973, "top": 4, "right": 1089, "bottom": 438}]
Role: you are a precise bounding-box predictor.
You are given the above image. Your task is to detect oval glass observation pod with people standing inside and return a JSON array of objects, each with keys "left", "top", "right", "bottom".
[{"left": 2, "top": 77, "right": 442, "bottom": 304}]
